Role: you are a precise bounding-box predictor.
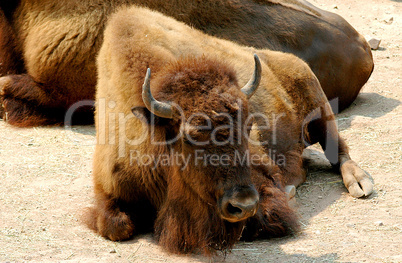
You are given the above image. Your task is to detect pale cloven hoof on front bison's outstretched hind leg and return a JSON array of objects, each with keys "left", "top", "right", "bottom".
[{"left": 341, "top": 160, "right": 373, "bottom": 197}]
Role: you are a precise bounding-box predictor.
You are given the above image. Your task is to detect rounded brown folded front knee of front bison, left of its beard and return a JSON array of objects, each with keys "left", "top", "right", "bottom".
[{"left": 96, "top": 212, "right": 134, "bottom": 241}]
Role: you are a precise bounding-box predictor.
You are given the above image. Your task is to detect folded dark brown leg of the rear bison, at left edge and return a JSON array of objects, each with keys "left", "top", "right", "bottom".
[{"left": 0, "top": 74, "right": 93, "bottom": 127}]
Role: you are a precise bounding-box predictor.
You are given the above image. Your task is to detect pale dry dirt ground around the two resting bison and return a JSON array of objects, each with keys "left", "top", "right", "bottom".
[{"left": 0, "top": 0, "right": 402, "bottom": 262}]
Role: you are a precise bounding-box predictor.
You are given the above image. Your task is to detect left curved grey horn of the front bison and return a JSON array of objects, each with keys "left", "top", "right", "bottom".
[{"left": 142, "top": 68, "right": 173, "bottom": 119}]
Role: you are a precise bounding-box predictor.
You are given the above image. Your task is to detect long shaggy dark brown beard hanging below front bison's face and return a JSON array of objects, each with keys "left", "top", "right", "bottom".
[{"left": 155, "top": 167, "right": 245, "bottom": 254}]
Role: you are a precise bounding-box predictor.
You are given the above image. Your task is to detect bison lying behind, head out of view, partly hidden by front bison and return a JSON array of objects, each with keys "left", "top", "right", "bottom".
[{"left": 0, "top": 0, "right": 373, "bottom": 126}]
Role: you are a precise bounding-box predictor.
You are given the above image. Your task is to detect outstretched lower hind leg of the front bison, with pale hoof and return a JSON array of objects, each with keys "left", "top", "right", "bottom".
[{"left": 308, "top": 105, "right": 373, "bottom": 197}]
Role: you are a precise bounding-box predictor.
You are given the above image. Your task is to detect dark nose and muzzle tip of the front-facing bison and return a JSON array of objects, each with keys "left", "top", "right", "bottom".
[{"left": 221, "top": 187, "right": 259, "bottom": 223}]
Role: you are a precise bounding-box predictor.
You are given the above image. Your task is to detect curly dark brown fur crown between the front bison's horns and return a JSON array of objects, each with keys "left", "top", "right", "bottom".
[{"left": 153, "top": 56, "right": 245, "bottom": 117}]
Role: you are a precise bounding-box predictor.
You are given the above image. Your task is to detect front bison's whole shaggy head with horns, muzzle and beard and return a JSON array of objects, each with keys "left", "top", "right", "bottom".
[{"left": 133, "top": 55, "right": 261, "bottom": 252}]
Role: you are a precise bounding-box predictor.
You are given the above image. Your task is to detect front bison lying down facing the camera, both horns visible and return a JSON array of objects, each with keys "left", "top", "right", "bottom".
[{"left": 86, "top": 7, "right": 373, "bottom": 253}]
